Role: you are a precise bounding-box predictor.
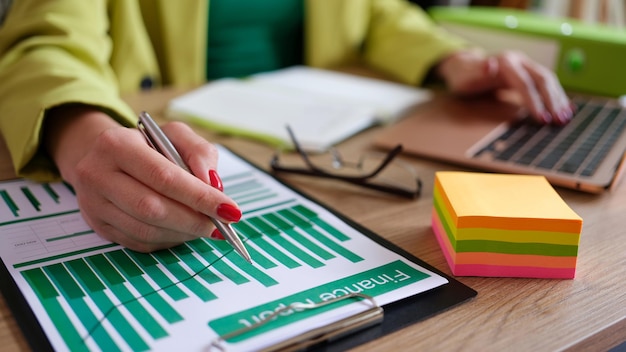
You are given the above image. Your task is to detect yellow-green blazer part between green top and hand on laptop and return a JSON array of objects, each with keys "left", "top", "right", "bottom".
[{"left": 305, "top": 0, "right": 467, "bottom": 84}]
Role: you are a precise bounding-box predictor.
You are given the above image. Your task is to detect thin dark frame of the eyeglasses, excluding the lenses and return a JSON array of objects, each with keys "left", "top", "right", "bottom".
[{"left": 270, "top": 126, "right": 422, "bottom": 199}]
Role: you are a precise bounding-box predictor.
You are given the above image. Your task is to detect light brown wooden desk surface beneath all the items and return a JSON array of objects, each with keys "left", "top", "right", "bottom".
[{"left": 0, "top": 90, "right": 626, "bottom": 351}]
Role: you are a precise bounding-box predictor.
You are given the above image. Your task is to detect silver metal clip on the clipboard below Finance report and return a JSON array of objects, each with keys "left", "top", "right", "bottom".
[{"left": 209, "top": 293, "right": 384, "bottom": 352}]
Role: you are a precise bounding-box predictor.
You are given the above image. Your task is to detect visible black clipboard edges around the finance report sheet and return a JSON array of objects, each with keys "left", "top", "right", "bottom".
[{"left": 0, "top": 146, "right": 477, "bottom": 351}]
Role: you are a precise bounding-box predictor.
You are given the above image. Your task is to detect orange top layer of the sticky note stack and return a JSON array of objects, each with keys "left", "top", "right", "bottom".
[{"left": 435, "top": 171, "right": 582, "bottom": 233}]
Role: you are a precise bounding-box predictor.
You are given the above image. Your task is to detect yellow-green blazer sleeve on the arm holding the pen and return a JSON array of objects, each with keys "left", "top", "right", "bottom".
[{"left": 0, "top": 0, "right": 135, "bottom": 180}]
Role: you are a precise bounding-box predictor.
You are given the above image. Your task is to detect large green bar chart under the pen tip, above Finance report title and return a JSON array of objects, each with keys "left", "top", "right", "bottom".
[{"left": 22, "top": 198, "right": 370, "bottom": 350}]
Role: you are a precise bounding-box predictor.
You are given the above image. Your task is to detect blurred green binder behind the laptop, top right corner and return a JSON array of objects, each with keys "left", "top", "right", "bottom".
[{"left": 410, "top": 0, "right": 626, "bottom": 97}]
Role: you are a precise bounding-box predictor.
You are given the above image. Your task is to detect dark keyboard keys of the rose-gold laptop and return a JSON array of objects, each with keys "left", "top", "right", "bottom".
[{"left": 474, "top": 99, "right": 626, "bottom": 176}]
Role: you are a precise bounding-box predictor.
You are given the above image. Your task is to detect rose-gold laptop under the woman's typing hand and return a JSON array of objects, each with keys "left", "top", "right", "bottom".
[{"left": 374, "top": 95, "right": 626, "bottom": 193}]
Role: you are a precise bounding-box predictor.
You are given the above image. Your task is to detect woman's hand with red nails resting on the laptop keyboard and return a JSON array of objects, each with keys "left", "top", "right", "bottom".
[{"left": 436, "top": 50, "right": 574, "bottom": 125}]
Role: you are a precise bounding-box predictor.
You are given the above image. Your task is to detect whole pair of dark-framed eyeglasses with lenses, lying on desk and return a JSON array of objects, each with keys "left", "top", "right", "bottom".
[{"left": 270, "top": 126, "right": 422, "bottom": 199}]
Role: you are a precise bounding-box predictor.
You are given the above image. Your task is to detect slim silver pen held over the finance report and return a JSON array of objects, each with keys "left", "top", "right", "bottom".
[{"left": 137, "top": 111, "right": 252, "bottom": 263}]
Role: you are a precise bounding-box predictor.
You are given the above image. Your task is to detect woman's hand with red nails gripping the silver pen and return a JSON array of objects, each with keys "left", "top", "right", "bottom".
[{"left": 45, "top": 107, "right": 241, "bottom": 252}]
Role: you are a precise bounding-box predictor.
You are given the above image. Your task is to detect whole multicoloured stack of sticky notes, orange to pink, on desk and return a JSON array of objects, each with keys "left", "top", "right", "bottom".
[{"left": 432, "top": 172, "right": 582, "bottom": 279}]
